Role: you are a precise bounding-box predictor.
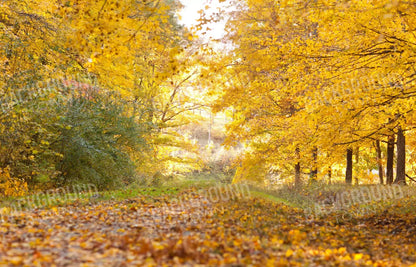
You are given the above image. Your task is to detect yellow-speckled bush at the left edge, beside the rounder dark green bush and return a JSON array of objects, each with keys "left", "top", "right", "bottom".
[{"left": 0, "top": 80, "right": 61, "bottom": 188}]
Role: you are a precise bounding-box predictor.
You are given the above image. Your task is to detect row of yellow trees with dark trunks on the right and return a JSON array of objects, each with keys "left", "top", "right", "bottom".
[{"left": 206, "top": 0, "right": 416, "bottom": 187}]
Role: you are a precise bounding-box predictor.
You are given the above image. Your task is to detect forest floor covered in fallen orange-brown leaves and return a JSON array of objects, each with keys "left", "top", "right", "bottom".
[{"left": 0, "top": 181, "right": 416, "bottom": 266}]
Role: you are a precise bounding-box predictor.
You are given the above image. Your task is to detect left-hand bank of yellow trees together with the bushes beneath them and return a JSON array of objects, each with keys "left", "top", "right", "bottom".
[{"left": 0, "top": 0, "right": 201, "bottom": 193}]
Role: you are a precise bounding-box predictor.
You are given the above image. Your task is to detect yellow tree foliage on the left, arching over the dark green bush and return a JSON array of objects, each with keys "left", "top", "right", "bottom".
[{"left": 0, "top": 0, "right": 202, "bottom": 188}]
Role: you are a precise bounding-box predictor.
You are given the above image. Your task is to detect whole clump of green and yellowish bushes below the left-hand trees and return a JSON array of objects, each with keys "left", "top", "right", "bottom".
[{"left": 0, "top": 78, "right": 154, "bottom": 190}]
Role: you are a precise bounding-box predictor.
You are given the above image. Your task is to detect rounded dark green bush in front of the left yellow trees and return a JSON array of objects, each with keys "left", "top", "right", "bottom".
[{"left": 55, "top": 87, "right": 149, "bottom": 189}]
